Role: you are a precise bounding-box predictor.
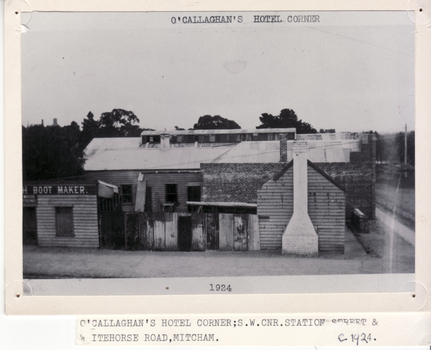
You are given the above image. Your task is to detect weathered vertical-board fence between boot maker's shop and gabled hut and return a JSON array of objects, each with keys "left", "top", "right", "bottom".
[{"left": 120, "top": 212, "right": 260, "bottom": 251}]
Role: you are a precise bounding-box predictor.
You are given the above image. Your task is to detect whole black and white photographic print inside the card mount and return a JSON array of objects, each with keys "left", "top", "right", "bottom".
[{"left": 20, "top": 11, "right": 416, "bottom": 295}]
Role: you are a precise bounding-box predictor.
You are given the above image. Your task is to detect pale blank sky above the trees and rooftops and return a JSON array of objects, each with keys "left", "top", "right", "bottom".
[{"left": 21, "top": 11, "right": 415, "bottom": 133}]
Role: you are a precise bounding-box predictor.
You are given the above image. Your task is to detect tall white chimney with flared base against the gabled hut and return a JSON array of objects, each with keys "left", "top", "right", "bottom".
[{"left": 282, "top": 141, "right": 319, "bottom": 255}]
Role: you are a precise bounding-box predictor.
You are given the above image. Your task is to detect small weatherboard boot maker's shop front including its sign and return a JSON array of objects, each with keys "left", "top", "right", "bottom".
[{"left": 23, "top": 182, "right": 99, "bottom": 248}]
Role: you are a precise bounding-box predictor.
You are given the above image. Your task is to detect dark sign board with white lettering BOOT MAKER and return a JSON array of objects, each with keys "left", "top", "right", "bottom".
[{"left": 22, "top": 184, "right": 96, "bottom": 205}]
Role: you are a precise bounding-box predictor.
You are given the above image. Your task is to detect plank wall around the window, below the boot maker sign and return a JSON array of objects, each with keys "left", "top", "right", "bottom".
[{"left": 36, "top": 195, "right": 99, "bottom": 248}]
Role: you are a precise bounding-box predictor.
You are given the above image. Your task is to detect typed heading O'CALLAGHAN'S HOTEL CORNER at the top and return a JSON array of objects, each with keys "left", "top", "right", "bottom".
[{"left": 171, "top": 13, "right": 321, "bottom": 24}]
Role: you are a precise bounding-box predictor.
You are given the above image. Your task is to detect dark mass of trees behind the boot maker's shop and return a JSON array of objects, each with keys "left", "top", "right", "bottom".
[{"left": 22, "top": 109, "right": 143, "bottom": 181}]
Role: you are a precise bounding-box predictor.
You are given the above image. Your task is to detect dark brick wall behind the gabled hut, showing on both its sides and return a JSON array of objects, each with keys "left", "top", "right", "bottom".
[{"left": 201, "top": 135, "right": 376, "bottom": 220}]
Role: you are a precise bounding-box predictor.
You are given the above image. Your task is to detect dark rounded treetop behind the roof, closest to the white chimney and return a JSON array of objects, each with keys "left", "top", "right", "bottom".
[{"left": 256, "top": 109, "right": 317, "bottom": 134}]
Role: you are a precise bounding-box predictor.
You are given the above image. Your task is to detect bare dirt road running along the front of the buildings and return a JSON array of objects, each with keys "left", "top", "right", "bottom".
[{"left": 23, "top": 223, "right": 414, "bottom": 279}]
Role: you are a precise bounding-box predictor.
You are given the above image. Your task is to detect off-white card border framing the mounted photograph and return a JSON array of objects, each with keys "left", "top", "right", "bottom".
[{"left": 4, "top": 0, "right": 431, "bottom": 322}]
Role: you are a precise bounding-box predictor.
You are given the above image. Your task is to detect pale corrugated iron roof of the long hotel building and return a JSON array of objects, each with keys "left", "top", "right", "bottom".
[{"left": 84, "top": 135, "right": 360, "bottom": 171}]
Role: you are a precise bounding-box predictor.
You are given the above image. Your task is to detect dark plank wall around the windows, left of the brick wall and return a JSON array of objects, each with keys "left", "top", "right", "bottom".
[{"left": 85, "top": 170, "right": 202, "bottom": 212}]
